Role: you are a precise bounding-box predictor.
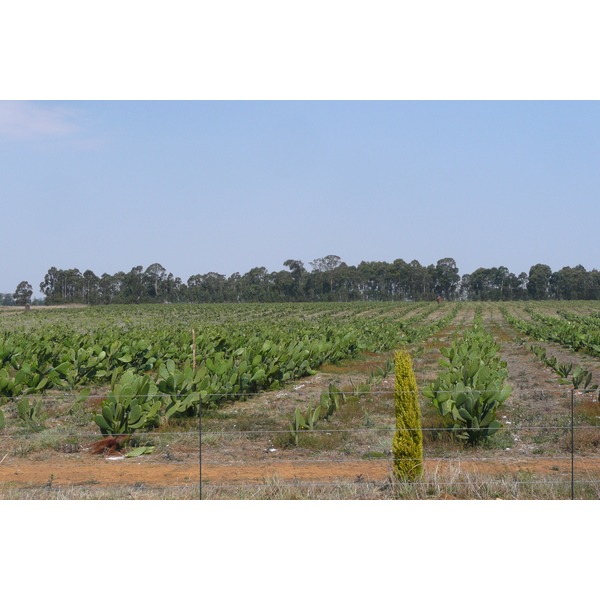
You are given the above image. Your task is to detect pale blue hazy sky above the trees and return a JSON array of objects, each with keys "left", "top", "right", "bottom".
[{"left": 0, "top": 101, "right": 600, "bottom": 296}]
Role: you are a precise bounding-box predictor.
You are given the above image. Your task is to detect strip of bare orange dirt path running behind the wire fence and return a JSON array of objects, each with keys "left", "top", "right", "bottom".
[{"left": 0, "top": 457, "right": 600, "bottom": 487}]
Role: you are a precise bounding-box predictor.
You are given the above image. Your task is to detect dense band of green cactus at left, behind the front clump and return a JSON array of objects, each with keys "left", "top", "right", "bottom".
[{"left": 0, "top": 305, "right": 455, "bottom": 406}]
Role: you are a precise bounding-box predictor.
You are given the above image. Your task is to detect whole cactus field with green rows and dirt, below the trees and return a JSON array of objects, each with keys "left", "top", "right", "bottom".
[{"left": 0, "top": 301, "right": 600, "bottom": 499}]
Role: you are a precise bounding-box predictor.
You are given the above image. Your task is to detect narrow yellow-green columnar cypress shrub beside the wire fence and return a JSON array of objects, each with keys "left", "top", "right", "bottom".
[{"left": 392, "top": 352, "right": 423, "bottom": 480}]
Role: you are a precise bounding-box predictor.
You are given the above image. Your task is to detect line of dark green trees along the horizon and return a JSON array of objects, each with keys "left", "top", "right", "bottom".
[{"left": 5, "top": 255, "right": 600, "bottom": 304}]
